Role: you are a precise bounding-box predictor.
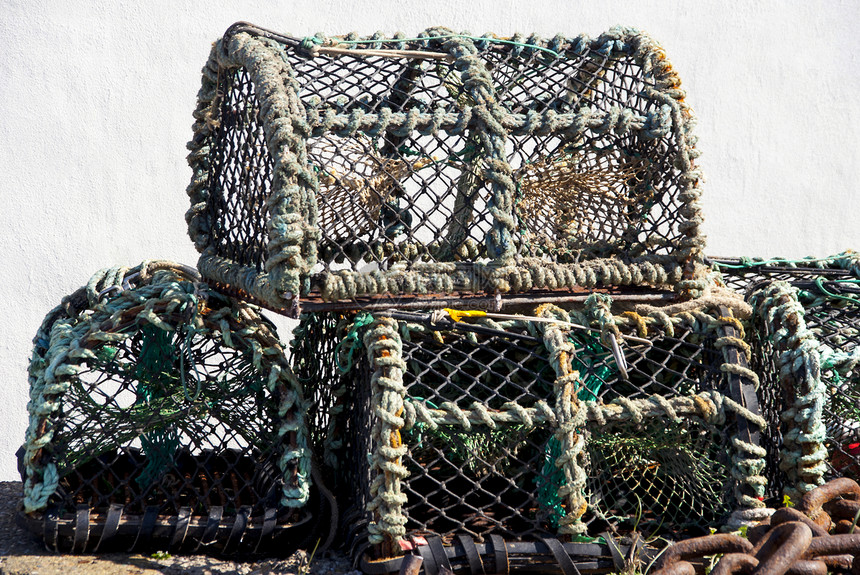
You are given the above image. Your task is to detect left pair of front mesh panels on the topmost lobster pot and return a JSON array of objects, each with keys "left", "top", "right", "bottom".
[{"left": 289, "top": 44, "right": 489, "bottom": 272}]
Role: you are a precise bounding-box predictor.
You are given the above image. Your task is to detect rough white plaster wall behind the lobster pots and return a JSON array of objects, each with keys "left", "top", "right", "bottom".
[{"left": 0, "top": 0, "right": 860, "bottom": 480}]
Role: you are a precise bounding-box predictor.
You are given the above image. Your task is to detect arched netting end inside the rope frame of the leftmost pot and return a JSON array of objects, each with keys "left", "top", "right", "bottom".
[{"left": 37, "top": 297, "right": 302, "bottom": 536}]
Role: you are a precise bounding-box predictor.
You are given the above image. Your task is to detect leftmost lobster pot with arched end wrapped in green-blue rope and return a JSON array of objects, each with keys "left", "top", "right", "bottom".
[{"left": 19, "top": 263, "right": 314, "bottom": 554}]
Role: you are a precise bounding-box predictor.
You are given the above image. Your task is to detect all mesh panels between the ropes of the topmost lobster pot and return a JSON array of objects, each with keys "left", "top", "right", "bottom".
[{"left": 207, "top": 33, "right": 688, "bottom": 287}]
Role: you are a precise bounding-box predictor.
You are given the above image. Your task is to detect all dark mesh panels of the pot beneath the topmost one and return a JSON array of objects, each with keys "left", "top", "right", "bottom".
[{"left": 294, "top": 314, "right": 752, "bottom": 560}]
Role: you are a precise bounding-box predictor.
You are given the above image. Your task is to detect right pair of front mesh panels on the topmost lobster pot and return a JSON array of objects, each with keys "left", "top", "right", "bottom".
[{"left": 486, "top": 49, "right": 684, "bottom": 262}]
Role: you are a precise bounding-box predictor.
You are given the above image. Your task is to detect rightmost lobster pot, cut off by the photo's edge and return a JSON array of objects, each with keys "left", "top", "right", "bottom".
[{"left": 717, "top": 252, "right": 860, "bottom": 500}]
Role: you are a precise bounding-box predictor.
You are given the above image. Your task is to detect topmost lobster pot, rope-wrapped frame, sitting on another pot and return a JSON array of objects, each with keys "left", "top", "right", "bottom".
[{"left": 187, "top": 25, "right": 704, "bottom": 313}]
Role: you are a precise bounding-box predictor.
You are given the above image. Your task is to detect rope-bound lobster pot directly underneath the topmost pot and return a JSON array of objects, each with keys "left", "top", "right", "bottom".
[{"left": 294, "top": 300, "right": 764, "bottom": 572}]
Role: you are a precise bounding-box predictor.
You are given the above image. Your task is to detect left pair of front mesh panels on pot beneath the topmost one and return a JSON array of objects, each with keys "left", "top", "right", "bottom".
[{"left": 396, "top": 326, "right": 555, "bottom": 540}]
